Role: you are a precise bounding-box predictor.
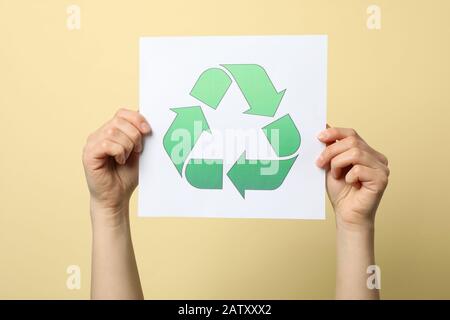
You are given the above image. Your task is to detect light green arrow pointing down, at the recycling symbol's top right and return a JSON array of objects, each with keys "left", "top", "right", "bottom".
[{"left": 222, "top": 64, "right": 286, "bottom": 117}]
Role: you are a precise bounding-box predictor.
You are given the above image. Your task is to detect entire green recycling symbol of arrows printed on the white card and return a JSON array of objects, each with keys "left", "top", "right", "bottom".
[{"left": 163, "top": 64, "right": 301, "bottom": 199}]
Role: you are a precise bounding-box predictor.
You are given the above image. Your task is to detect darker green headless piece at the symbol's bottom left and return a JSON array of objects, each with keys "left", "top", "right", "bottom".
[{"left": 185, "top": 159, "right": 223, "bottom": 189}]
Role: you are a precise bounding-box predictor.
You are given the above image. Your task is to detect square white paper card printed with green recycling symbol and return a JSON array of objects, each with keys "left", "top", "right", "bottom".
[{"left": 138, "top": 35, "right": 327, "bottom": 219}]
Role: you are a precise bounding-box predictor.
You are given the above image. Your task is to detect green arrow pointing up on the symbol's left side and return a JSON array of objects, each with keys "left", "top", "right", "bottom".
[{"left": 163, "top": 106, "right": 211, "bottom": 175}]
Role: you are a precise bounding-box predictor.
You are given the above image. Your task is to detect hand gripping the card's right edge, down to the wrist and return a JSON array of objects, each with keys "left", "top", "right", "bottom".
[{"left": 317, "top": 128, "right": 389, "bottom": 230}]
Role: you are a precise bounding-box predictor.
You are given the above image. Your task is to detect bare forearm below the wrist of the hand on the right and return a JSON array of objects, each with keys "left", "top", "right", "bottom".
[{"left": 336, "top": 222, "right": 379, "bottom": 300}]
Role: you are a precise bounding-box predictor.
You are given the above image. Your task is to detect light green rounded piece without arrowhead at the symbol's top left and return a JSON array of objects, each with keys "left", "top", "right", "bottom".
[{"left": 190, "top": 68, "right": 231, "bottom": 109}]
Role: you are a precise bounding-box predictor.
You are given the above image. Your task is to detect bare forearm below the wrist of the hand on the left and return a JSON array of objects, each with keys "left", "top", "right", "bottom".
[{"left": 91, "top": 205, "right": 143, "bottom": 299}]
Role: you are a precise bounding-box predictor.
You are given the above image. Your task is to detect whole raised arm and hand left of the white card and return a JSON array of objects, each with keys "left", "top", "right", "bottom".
[{"left": 83, "top": 109, "right": 151, "bottom": 299}]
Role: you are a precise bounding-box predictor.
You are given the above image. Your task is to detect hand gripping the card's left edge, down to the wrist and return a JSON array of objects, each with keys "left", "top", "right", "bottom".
[{"left": 83, "top": 109, "right": 151, "bottom": 212}]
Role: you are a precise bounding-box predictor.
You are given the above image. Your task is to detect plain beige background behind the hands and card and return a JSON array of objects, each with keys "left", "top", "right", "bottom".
[{"left": 0, "top": 0, "right": 450, "bottom": 299}]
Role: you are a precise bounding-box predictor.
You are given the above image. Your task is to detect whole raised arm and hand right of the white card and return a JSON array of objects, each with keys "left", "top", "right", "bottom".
[{"left": 317, "top": 128, "right": 389, "bottom": 299}]
